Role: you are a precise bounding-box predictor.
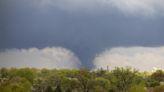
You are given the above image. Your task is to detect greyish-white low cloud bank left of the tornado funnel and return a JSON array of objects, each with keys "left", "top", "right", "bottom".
[{"left": 0, "top": 47, "right": 81, "bottom": 69}]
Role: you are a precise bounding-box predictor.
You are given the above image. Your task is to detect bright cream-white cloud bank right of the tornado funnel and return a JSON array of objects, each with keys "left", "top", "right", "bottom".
[{"left": 93, "top": 47, "right": 164, "bottom": 71}]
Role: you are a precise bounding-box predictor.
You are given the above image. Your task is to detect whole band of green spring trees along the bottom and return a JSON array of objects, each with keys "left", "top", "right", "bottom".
[{"left": 0, "top": 68, "right": 164, "bottom": 92}]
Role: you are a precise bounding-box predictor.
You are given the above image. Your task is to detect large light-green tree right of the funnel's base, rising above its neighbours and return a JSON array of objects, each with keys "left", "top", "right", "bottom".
[{"left": 108, "top": 68, "right": 137, "bottom": 92}]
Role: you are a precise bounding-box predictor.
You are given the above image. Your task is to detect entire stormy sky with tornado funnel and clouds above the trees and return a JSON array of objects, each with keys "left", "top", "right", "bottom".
[{"left": 0, "top": 0, "right": 164, "bottom": 71}]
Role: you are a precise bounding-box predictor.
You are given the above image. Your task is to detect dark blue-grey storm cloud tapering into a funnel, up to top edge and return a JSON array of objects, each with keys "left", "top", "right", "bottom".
[{"left": 0, "top": 0, "right": 164, "bottom": 68}]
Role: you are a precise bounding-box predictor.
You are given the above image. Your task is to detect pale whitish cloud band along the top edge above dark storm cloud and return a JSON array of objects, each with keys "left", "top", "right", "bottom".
[{"left": 34, "top": 0, "right": 164, "bottom": 16}]
